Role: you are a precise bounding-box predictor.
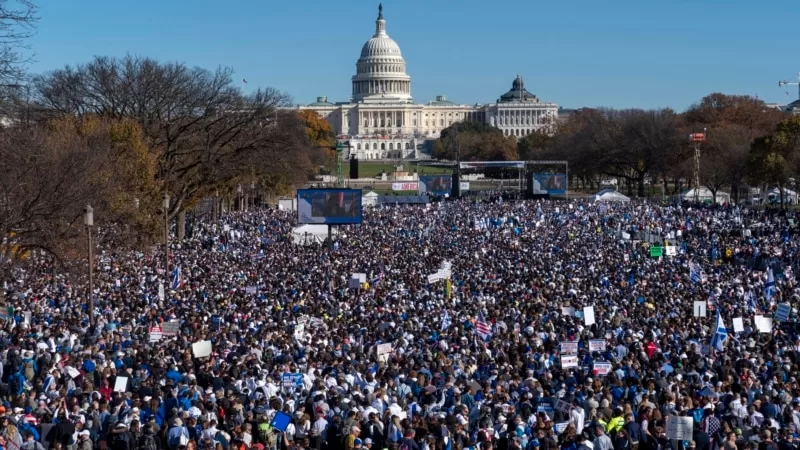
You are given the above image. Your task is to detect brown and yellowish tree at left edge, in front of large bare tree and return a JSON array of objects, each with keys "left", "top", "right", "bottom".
[{"left": 0, "top": 116, "right": 159, "bottom": 272}]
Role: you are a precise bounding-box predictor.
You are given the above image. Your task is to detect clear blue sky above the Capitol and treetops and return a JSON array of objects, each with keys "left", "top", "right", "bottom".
[{"left": 30, "top": 0, "right": 800, "bottom": 110}]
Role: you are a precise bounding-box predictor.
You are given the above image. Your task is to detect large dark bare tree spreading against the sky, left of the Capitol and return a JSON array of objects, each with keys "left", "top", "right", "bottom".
[{"left": 35, "top": 56, "right": 316, "bottom": 223}]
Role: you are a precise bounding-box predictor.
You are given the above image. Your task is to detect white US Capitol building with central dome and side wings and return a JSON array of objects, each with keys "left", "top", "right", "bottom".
[{"left": 296, "top": 5, "right": 558, "bottom": 160}]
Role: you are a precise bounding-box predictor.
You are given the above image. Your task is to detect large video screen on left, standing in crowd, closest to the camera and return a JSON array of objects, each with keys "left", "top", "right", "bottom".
[{"left": 297, "top": 189, "right": 361, "bottom": 225}]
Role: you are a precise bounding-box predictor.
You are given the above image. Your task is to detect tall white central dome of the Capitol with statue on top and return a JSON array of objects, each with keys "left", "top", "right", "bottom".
[{"left": 353, "top": 5, "right": 411, "bottom": 103}]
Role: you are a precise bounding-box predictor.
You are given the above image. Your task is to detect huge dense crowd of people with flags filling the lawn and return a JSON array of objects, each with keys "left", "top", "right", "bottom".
[{"left": 0, "top": 200, "right": 800, "bottom": 450}]
